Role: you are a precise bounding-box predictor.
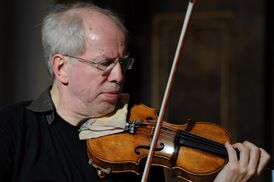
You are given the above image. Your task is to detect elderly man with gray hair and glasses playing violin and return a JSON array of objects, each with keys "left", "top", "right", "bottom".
[{"left": 0, "top": 3, "right": 270, "bottom": 182}]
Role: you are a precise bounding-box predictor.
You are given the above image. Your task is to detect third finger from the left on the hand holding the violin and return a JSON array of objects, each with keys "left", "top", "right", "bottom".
[{"left": 243, "top": 141, "right": 261, "bottom": 178}]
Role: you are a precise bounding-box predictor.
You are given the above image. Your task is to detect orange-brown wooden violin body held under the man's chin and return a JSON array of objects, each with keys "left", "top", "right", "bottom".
[{"left": 87, "top": 105, "right": 231, "bottom": 181}]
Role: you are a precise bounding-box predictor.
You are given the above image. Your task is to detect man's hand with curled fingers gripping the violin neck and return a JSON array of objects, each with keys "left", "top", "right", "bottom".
[{"left": 214, "top": 141, "right": 270, "bottom": 182}]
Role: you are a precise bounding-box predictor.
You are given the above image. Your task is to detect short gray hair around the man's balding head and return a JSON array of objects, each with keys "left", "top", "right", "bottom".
[{"left": 42, "top": 1, "right": 127, "bottom": 78}]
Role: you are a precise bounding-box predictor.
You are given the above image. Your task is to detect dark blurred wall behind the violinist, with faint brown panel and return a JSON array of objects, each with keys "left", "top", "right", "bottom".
[{"left": 0, "top": 0, "right": 274, "bottom": 181}]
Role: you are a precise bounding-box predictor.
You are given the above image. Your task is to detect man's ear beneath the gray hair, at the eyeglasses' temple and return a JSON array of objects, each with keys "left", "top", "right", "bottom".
[{"left": 51, "top": 54, "right": 69, "bottom": 85}]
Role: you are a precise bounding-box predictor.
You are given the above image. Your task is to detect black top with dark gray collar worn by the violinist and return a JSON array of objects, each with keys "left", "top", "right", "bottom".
[{"left": 0, "top": 88, "right": 146, "bottom": 182}]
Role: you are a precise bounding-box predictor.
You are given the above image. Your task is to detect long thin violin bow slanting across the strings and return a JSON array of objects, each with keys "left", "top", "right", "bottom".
[{"left": 142, "top": 0, "right": 195, "bottom": 182}]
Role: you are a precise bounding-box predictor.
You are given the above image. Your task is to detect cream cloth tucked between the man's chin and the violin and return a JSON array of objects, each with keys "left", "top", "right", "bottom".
[{"left": 79, "top": 93, "right": 129, "bottom": 140}]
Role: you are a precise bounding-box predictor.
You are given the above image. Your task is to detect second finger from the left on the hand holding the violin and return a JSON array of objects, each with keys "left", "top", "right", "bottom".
[{"left": 233, "top": 143, "right": 249, "bottom": 177}]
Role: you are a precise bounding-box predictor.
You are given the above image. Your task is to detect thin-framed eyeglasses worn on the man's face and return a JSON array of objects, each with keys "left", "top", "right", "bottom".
[{"left": 64, "top": 54, "right": 134, "bottom": 73}]
